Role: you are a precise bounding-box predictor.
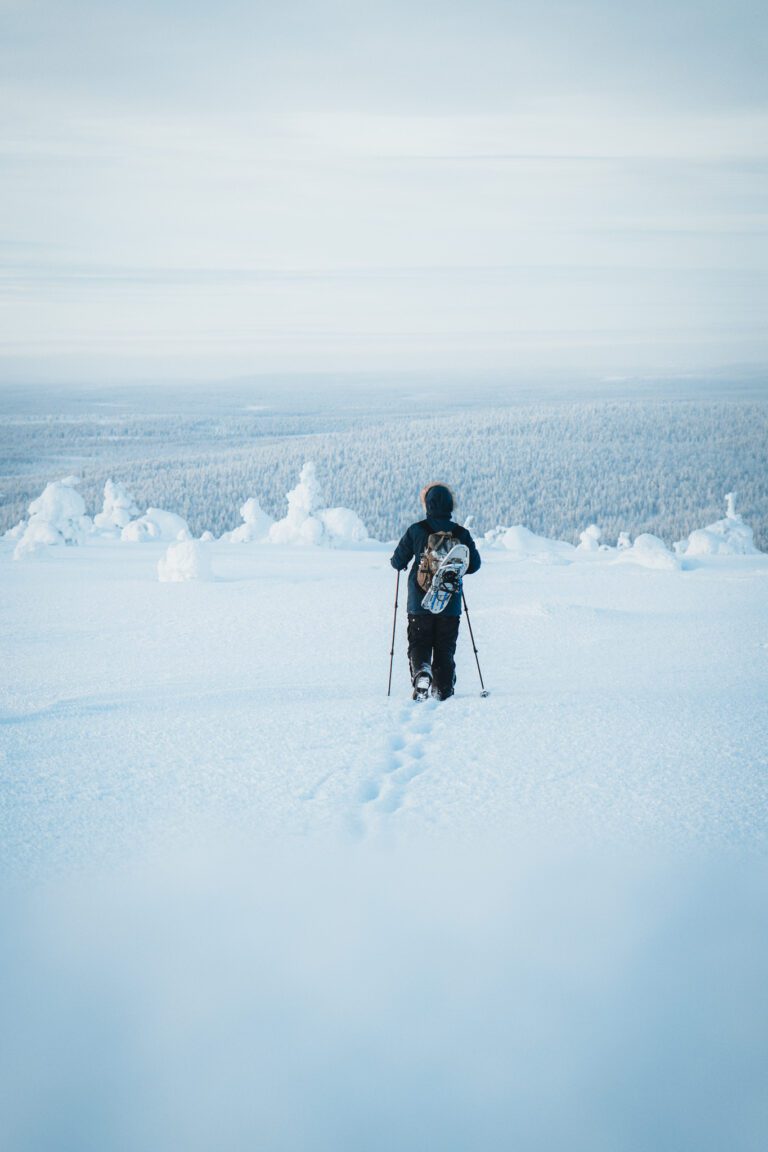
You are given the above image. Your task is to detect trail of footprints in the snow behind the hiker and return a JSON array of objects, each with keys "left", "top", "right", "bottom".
[{"left": 359, "top": 700, "right": 439, "bottom": 816}]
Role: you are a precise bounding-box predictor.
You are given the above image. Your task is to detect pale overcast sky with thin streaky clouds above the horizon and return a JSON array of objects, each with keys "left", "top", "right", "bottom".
[{"left": 0, "top": 0, "right": 768, "bottom": 381}]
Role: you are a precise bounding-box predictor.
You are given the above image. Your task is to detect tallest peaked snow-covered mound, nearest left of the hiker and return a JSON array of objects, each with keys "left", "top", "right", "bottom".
[{"left": 267, "top": 461, "right": 371, "bottom": 548}]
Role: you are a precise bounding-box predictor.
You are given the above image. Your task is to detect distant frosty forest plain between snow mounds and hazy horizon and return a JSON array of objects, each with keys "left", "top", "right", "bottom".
[{"left": 0, "top": 400, "right": 768, "bottom": 551}]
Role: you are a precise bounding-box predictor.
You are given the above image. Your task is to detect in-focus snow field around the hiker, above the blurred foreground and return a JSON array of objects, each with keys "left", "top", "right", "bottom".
[{"left": 2, "top": 541, "right": 768, "bottom": 871}]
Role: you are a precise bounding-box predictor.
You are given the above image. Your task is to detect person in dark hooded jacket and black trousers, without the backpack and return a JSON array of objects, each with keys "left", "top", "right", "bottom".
[{"left": 390, "top": 484, "right": 480, "bottom": 700}]
